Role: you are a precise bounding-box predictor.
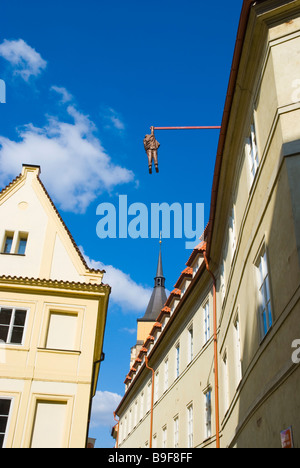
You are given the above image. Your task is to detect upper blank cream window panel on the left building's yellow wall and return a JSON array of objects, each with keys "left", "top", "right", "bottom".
[{"left": 46, "top": 312, "right": 78, "bottom": 351}]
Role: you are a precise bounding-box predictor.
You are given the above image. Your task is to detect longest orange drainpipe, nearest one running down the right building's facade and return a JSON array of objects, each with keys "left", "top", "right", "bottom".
[{"left": 203, "top": 251, "right": 220, "bottom": 448}]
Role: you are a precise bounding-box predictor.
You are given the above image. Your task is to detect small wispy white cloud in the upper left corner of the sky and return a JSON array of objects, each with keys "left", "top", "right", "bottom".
[{"left": 0, "top": 39, "right": 47, "bottom": 81}]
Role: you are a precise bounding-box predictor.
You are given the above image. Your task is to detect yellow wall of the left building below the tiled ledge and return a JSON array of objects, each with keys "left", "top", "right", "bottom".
[{"left": 0, "top": 285, "right": 105, "bottom": 448}]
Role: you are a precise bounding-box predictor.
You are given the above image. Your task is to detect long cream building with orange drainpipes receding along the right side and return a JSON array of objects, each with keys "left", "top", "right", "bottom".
[{"left": 114, "top": 0, "right": 300, "bottom": 448}]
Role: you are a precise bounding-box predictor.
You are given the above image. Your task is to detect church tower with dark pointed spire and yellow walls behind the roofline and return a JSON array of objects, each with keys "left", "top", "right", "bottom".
[{"left": 130, "top": 241, "right": 167, "bottom": 367}]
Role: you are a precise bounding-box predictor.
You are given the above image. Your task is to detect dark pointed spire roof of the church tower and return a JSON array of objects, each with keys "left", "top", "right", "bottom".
[{"left": 141, "top": 241, "right": 167, "bottom": 322}]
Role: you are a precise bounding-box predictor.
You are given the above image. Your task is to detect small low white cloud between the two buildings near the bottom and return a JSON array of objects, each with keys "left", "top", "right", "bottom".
[{"left": 91, "top": 391, "right": 122, "bottom": 428}]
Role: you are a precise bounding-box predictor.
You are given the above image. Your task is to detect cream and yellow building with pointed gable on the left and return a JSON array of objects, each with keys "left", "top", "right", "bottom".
[{"left": 0, "top": 165, "right": 110, "bottom": 448}]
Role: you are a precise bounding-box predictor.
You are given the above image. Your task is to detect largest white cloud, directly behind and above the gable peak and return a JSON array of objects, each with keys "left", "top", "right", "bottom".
[{"left": 0, "top": 98, "right": 134, "bottom": 213}]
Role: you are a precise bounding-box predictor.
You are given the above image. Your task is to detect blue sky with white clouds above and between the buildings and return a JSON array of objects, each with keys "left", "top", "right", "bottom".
[{"left": 0, "top": 0, "right": 242, "bottom": 447}]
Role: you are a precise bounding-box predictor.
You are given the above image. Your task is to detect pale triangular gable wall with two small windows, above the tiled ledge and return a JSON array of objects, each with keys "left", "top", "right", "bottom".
[{"left": 0, "top": 167, "right": 87, "bottom": 282}]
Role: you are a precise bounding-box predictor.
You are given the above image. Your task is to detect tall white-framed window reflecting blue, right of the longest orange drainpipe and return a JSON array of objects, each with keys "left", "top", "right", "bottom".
[{"left": 256, "top": 250, "right": 273, "bottom": 338}]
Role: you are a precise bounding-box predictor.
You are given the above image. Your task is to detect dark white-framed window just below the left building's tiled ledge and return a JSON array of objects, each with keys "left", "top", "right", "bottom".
[{"left": 0, "top": 307, "right": 27, "bottom": 345}]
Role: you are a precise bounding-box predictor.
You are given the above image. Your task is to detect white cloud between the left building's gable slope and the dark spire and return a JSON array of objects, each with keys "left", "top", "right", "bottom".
[{"left": 80, "top": 247, "right": 152, "bottom": 313}]
